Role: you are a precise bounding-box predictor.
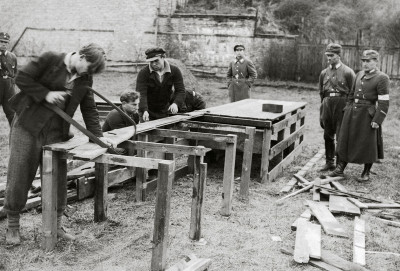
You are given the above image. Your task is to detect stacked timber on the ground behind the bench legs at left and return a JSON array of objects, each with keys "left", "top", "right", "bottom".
[{"left": 0, "top": 161, "right": 134, "bottom": 219}]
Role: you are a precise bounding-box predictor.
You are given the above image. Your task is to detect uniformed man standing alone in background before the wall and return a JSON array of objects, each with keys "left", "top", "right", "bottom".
[{"left": 226, "top": 44, "right": 257, "bottom": 102}]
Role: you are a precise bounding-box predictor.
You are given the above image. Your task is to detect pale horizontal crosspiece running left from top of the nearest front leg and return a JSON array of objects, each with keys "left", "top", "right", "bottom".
[{"left": 93, "top": 153, "right": 163, "bottom": 169}]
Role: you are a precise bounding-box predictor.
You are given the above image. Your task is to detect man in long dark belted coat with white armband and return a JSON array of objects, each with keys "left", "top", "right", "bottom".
[{"left": 331, "top": 50, "right": 390, "bottom": 182}]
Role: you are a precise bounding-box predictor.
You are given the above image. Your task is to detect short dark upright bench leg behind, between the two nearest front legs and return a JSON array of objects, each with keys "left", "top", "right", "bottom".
[{"left": 94, "top": 163, "right": 108, "bottom": 222}]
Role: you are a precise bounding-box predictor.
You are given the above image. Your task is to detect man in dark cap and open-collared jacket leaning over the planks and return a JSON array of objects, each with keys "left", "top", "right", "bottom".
[{"left": 136, "top": 47, "right": 185, "bottom": 122}]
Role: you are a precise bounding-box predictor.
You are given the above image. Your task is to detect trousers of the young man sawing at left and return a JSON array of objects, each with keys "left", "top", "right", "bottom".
[{"left": 4, "top": 115, "right": 67, "bottom": 215}]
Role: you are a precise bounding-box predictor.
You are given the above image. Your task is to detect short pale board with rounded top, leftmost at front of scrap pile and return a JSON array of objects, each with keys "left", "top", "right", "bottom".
[{"left": 293, "top": 219, "right": 310, "bottom": 263}]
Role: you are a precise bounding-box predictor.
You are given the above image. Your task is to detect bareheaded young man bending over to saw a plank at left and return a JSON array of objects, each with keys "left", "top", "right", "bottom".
[{"left": 4, "top": 44, "right": 112, "bottom": 245}]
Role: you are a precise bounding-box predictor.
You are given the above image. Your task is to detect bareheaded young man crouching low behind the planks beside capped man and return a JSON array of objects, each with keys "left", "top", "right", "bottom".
[{"left": 101, "top": 91, "right": 139, "bottom": 132}]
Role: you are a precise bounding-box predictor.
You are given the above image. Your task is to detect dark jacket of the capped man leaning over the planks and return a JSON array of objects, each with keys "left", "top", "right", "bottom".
[{"left": 136, "top": 62, "right": 185, "bottom": 119}]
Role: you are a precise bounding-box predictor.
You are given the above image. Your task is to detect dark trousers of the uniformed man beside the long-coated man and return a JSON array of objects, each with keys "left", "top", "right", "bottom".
[{"left": 320, "top": 97, "right": 347, "bottom": 160}]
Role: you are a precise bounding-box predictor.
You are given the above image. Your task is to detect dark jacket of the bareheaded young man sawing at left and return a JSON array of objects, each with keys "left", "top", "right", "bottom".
[{"left": 10, "top": 52, "right": 103, "bottom": 140}]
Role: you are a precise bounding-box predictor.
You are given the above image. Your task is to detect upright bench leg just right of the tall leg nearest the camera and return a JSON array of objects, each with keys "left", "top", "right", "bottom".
[{"left": 189, "top": 156, "right": 207, "bottom": 241}]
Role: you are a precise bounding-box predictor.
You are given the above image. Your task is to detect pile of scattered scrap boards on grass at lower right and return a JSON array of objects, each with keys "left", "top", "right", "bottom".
[{"left": 277, "top": 152, "right": 400, "bottom": 271}]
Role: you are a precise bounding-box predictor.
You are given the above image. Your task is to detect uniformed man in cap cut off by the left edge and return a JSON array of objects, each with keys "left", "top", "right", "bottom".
[{"left": 0, "top": 32, "right": 17, "bottom": 126}]
